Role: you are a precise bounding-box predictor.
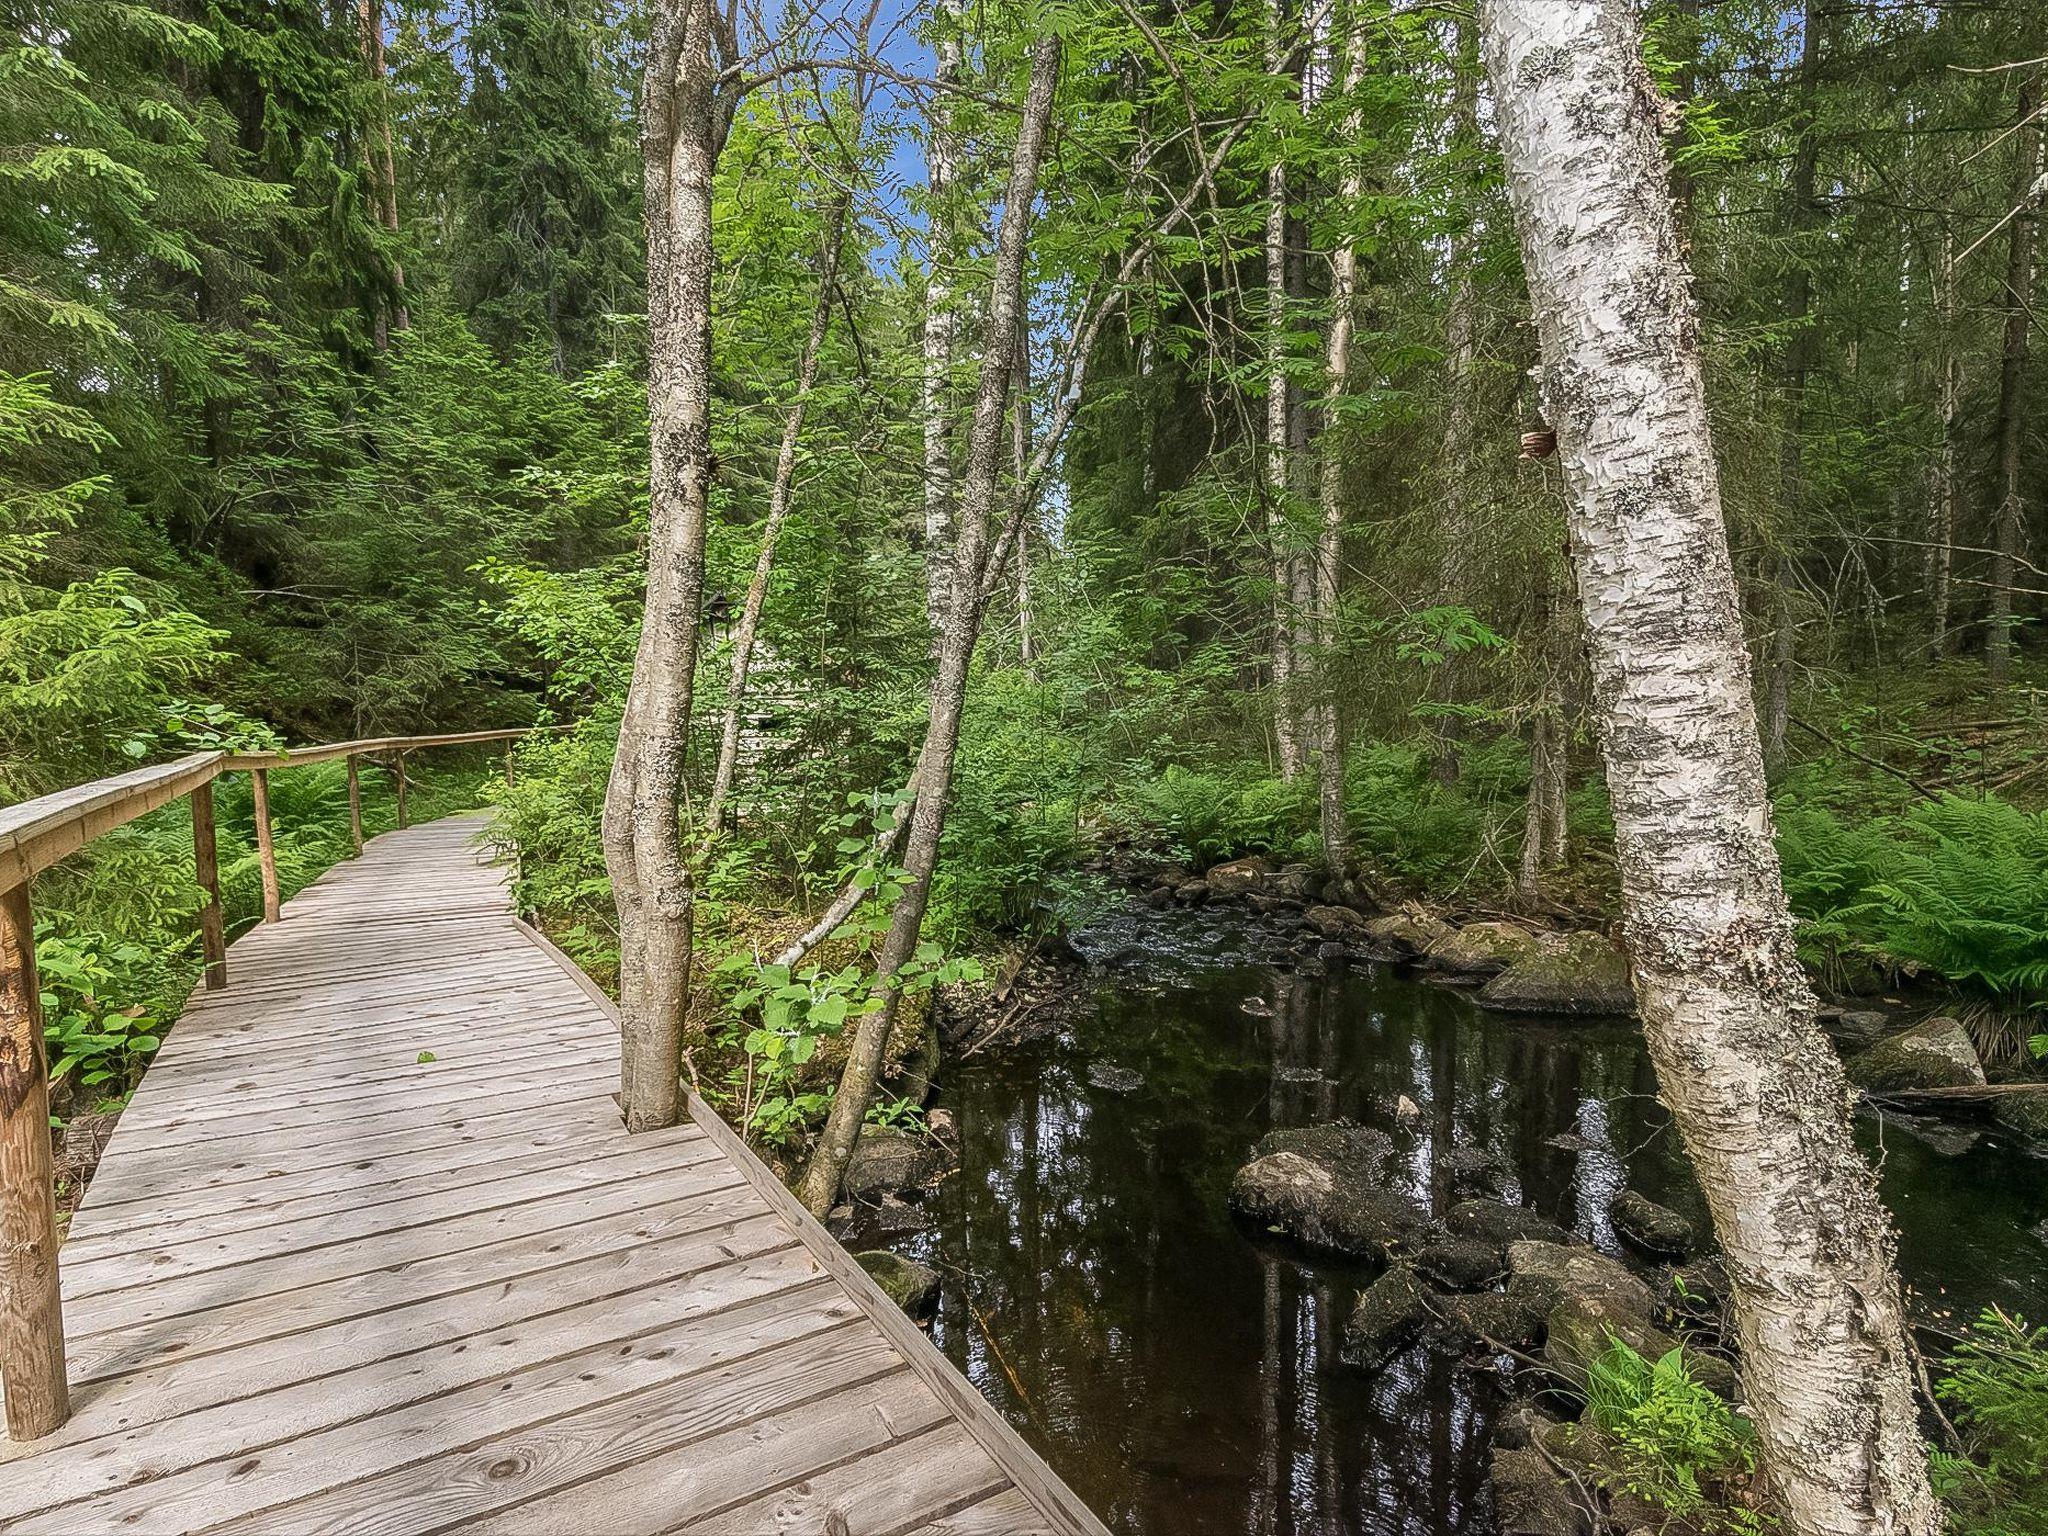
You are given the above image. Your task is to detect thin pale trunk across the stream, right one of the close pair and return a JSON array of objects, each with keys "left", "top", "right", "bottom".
[{"left": 1315, "top": 12, "right": 1366, "bottom": 874}]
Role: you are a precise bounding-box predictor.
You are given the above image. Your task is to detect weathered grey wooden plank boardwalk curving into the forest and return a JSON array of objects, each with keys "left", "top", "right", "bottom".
[{"left": 0, "top": 819, "right": 1102, "bottom": 1536}]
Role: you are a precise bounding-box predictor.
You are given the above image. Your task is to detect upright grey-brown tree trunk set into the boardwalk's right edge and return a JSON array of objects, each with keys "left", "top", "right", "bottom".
[{"left": 604, "top": 0, "right": 727, "bottom": 1130}]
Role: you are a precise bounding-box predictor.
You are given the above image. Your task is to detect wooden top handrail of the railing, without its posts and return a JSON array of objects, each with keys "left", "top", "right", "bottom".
[{"left": 0, "top": 725, "right": 571, "bottom": 891}]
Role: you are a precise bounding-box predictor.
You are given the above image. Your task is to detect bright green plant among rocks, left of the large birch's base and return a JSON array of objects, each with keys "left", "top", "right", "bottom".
[{"left": 1585, "top": 1337, "right": 1767, "bottom": 1532}]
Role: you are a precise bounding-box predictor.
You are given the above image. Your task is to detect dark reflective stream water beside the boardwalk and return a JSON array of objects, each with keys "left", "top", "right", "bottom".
[{"left": 897, "top": 911, "right": 2048, "bottom": 1536}]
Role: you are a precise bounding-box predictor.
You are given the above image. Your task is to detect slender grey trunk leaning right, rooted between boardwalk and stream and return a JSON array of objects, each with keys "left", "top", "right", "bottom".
[{"left": 799, "top": 37, "right": 1059, "bottom": 1217}]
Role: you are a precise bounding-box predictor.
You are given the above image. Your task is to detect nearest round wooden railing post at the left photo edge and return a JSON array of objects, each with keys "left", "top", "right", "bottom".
[{"left": 0, "top": 885, "right": 72, "bottom": 1440}]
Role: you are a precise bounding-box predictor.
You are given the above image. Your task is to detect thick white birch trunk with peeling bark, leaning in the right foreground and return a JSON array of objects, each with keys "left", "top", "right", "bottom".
[{"left": 1481, "top": 0, "right": 1942, "bottom": 1536}]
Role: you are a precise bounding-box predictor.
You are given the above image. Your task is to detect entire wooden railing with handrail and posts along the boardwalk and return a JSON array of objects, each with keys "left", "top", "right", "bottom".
[{"left": 0, "top": 725, "right": 569, "bottom": 1440}]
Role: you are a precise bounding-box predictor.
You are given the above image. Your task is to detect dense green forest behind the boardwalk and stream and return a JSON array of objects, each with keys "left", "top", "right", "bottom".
[{"left": 0, "top": 0, "right": 2048, "bottom": 1081}]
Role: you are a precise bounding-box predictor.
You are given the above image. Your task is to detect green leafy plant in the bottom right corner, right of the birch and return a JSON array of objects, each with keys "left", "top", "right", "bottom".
[{"left": 1933, "top": 1307, "right": 2048, "bottom": 1536}]
